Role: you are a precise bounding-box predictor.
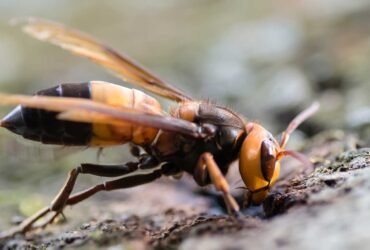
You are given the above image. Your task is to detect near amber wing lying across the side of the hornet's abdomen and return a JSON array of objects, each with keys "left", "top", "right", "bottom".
[{"left": 0, "top": 93, "right": 206, "bottom": 138}]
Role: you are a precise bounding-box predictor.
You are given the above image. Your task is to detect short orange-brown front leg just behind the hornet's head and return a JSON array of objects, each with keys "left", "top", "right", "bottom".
[{"left": 197, "top": 152, "right": 239, "bottom": 216}]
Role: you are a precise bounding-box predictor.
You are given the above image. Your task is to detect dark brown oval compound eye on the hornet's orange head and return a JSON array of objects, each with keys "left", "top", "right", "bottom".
[{"left": 261, "top": 139, "right": 276, "bottom": 182}]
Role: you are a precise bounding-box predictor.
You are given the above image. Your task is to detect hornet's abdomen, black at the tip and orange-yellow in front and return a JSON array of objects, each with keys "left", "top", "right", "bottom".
[{"left": 2, "top": 81, "right": 162, "bottom": 146}]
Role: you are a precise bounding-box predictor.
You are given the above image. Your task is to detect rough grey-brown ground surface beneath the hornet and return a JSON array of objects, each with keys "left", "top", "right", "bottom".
[{"left": 1, "top": 131, "right": 370, "bottom": 250}]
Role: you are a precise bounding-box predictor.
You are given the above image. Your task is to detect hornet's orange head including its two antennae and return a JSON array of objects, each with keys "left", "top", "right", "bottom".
[{"left": 239, "top": 103, "right": 319, "bottom": 204}]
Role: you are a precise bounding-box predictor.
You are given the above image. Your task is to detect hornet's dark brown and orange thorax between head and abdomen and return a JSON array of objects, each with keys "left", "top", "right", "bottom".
[{"left": 149, "top": 102, "right": 246, "bottom": 180}]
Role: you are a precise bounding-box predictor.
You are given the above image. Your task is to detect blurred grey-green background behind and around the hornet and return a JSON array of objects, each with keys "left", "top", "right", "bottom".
[{"left": 0, "top": 0, "right": 370, "bottom": 229}]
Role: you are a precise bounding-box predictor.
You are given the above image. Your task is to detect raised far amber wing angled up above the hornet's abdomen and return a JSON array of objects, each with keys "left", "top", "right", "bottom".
[{"left": 15, "top": 18, "right": 191, "bottom": 101}]
